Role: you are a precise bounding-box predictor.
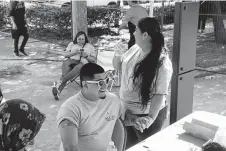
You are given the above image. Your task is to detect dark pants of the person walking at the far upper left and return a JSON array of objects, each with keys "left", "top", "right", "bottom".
[{"left": 11, "top": 27, "right": 29, "bottom": 53}]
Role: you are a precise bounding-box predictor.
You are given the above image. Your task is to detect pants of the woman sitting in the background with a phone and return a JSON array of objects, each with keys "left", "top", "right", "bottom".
[{"left": 58, "top": 59, "right": 83, "bottom": 92}]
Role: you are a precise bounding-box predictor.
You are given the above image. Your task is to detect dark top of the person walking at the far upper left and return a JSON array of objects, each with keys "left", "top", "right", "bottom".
[{"left": 9, "top": 1, "right": 26, "bottom": 28}]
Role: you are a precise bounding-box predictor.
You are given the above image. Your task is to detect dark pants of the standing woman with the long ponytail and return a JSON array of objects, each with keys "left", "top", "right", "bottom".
[{"left": 126, "top": 106, "right": 167, "bottom": 149}]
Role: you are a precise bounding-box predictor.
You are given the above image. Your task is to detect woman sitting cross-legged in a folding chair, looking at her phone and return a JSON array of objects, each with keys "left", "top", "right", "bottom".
[{"left": 52, "top": 31, "right": 97, "bottom": 100}]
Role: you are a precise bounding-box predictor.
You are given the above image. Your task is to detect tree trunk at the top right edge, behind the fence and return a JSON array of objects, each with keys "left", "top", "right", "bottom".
[{"left": 213, "top": 1, "right": 226, "bottom": 44}]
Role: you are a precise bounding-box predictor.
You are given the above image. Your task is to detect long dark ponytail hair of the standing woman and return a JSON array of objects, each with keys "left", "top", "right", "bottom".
[{"left": 133, "top": 17, "right": 164, "bottom": 107}]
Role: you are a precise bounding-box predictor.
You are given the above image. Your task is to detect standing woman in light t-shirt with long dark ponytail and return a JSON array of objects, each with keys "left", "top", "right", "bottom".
[{"left": 113, "top": 17, "right": 172, "bottom": 148}]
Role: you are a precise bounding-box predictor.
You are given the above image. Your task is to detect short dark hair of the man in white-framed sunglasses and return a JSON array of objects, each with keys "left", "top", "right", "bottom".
[{"left": 80, "top": 63, "right": 105, "bottom": 86}]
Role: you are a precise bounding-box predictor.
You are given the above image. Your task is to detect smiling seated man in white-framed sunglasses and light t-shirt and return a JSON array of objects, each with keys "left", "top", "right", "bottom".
[{"left": 57, "top": 63, "right": 121, "bottom": 151}]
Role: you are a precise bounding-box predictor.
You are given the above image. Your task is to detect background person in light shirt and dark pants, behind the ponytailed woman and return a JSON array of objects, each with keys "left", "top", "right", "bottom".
[{"left": 118, "top": 0, "right": 148, "bottom": 49}]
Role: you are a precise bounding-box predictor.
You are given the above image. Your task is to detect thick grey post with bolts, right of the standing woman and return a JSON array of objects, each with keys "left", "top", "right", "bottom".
[{"left": 170, "top": 2, "right": 199, "bottom": 124}]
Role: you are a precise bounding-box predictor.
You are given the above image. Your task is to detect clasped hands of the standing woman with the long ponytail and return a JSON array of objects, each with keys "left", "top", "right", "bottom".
[{"left": 134, "top": 116, "right": 154, "bottom": 133}]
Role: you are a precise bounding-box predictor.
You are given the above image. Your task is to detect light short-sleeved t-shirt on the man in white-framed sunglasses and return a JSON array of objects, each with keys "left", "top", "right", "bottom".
[{"left": 57, "top": 92, "right": 121, "bottom": 151}]
